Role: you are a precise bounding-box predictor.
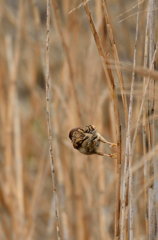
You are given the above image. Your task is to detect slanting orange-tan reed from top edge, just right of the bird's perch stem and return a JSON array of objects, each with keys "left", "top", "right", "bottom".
[{"left": 102, "top": 0, "right": 128, "bottom": 128}]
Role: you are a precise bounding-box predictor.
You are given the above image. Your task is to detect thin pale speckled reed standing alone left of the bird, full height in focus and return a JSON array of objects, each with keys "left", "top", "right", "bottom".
[{"left": 46, "top": 0, "right": 61, "bottom": 240}]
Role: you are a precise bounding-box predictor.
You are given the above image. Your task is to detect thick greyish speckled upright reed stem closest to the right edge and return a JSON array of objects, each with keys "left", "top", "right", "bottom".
[{"left": 148, "top": 0, "right": 157, "bottom": 237}]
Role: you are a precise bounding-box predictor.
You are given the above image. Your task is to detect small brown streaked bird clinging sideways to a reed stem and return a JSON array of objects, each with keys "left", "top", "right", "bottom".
[{"left": 69, "top": 125, "right": 117, "bottom": 158}]
